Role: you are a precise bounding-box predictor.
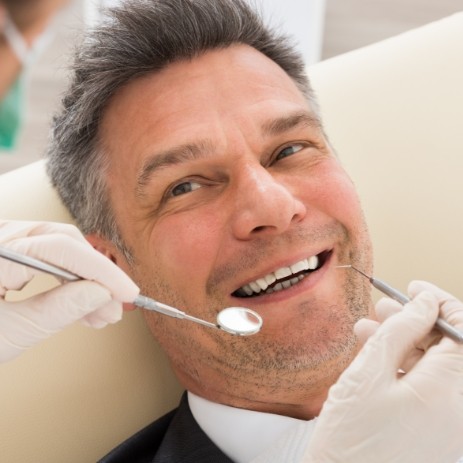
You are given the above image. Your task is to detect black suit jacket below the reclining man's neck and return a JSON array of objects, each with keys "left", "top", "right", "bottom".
[{"left": 99, "top": 394, "right": 233, "bottom": 463}]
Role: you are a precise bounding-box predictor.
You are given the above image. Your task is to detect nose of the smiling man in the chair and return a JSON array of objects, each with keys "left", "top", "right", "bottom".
[{"left": 232, "top": 165, "right": 306, "bottom": 240}]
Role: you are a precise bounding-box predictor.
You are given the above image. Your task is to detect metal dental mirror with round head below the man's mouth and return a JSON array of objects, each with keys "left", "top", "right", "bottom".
[{"left": 0, "top": 246, "right": 262, "bottom": 336}]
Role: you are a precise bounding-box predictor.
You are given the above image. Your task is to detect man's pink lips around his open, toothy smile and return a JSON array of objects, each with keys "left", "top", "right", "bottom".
[{"left": 232, "top": 248, "right": 334, "bottom": 306}]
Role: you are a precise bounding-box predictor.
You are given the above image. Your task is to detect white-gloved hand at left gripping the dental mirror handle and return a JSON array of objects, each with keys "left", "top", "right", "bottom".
[{"left": 0, "top": 221, "right": 139, "bottom": 362}]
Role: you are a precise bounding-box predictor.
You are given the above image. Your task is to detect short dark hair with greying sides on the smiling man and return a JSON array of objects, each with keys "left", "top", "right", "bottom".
[{"left": 47, "top": 0, "right": 317, "bottom": 261}]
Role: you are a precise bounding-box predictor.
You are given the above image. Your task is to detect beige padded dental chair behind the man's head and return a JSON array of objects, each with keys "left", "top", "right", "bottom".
[{"left": 0, "top": 13, "right": 463, "bottom": 463}]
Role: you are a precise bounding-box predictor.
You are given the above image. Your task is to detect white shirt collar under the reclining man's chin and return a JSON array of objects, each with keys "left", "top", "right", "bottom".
[{"left": 188, "top": 392, "right": 316, "bottom": 463}]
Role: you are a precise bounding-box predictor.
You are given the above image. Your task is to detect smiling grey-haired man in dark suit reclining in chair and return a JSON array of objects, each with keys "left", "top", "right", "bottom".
[{"left": 2, "top": 0, "right": 461, "bottom": 462}]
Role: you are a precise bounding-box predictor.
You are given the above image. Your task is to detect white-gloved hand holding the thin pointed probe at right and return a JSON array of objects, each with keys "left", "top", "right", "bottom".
[{"left": 303, "top": 282, "right": 463, "bottom": 463}]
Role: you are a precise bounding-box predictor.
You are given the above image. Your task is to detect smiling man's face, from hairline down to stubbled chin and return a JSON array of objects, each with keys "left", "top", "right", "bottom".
[{"left": 101, "top": 46, "right": 371, "bottom": 416}]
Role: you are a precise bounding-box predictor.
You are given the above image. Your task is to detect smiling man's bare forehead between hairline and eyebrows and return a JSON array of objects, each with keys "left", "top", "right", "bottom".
[{"left": 100, "top": 45, "right": 314, "bottom": 178}]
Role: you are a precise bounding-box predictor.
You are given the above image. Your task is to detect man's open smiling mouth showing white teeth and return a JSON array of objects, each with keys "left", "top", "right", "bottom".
[{"left": 232, "top": 251, "right": 331, "bottom": 297}]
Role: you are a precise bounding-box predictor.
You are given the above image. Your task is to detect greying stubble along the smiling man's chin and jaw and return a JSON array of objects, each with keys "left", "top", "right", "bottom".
[{"left": 134, "top": 219, "right": 371, "bottom": 401}]
